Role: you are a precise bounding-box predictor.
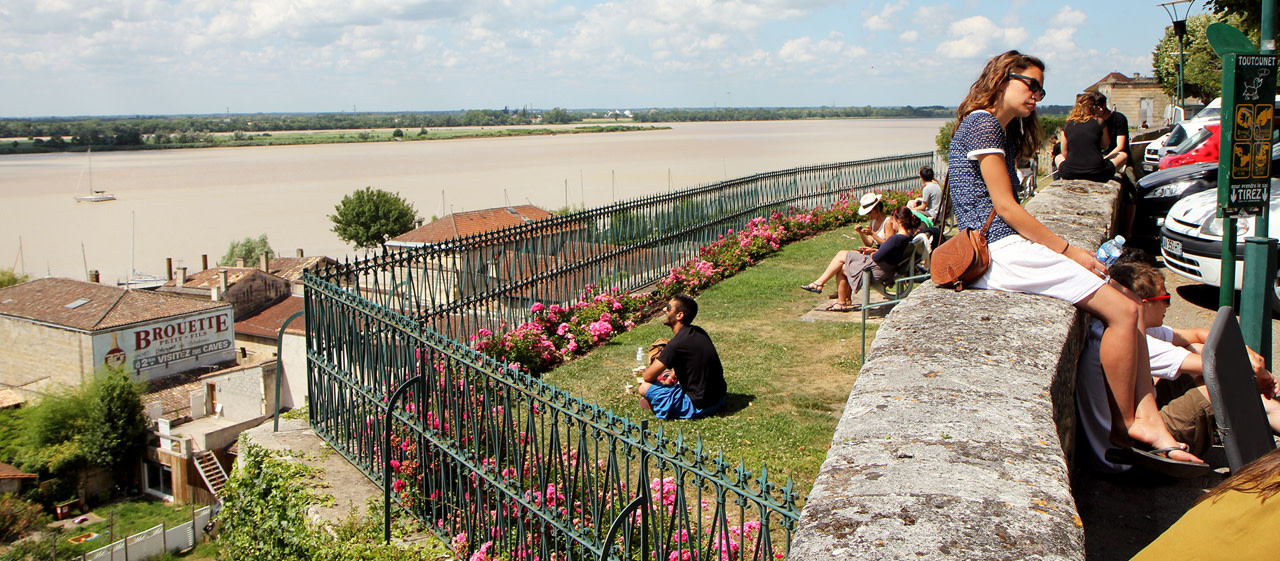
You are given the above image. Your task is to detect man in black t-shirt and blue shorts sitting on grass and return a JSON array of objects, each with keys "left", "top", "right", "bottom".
[{"left": 640, "top": 295, "right": 726, "bottom": 419}]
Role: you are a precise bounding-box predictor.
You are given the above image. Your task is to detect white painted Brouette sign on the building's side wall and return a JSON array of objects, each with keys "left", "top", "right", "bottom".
[{"left": 93, "top": 309, "right": 236, "bottom": 379}]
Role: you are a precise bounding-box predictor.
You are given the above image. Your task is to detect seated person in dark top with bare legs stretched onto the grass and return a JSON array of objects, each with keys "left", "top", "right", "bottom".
[{"left": 800, "top": 206, "right": 920, "bottom": 311}]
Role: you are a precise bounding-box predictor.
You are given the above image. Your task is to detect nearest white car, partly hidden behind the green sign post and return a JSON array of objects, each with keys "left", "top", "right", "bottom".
[{"left": 1160, "top": 185, "right": 1280, "bottom": 313}]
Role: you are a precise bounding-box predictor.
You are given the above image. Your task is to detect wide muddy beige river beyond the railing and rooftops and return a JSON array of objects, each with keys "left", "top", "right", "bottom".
[{"left": 0, "top": 119, "right": 943, "bottom": 283}]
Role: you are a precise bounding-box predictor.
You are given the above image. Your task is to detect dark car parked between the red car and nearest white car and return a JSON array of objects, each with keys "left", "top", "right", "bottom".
[{"left": 1130, "top": 142, "right": 1280, "bottom": 243}]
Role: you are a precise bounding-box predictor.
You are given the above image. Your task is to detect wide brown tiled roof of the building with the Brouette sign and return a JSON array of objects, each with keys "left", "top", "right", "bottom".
[{"left": 0, "top": 278, "right": 230, "bottom": 332}]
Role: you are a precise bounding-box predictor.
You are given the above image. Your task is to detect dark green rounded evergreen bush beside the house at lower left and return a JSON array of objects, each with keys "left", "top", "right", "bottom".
[{"left": 84, "top": 370, "right": 147, "bottom": 480}]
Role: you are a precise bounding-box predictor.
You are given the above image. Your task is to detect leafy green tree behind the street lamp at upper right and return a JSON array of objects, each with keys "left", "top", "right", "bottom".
[{"left": 1151, "top": 14, "right": 1258, "bottom": 102}]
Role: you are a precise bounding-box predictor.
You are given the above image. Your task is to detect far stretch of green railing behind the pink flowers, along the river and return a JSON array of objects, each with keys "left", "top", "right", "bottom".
[{"left": 309, "top": 152, "right": 933, "bottom": 341}]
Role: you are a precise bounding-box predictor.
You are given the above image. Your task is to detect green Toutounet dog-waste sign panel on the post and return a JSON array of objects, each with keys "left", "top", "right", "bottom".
[{"left": 1217, "top": 53, "right": 1276, "bottom": 215}]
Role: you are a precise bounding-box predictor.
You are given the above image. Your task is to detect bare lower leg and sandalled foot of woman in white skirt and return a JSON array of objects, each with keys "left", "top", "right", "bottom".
[{"left": 1076, "top": 286, "right": 1199, "bottom": 461}]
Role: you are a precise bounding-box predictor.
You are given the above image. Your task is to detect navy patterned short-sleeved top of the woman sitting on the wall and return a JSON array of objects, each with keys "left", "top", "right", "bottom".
[{"left": 947, "top": 110, "right": 1021, "bottom": 243}]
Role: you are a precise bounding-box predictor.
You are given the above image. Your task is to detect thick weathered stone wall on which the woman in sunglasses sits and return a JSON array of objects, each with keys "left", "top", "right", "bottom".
[{"left": 788, "top": 181, "right": 1119, "bottom": 561}]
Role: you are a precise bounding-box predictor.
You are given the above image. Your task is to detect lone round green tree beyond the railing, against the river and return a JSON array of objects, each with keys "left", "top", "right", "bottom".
[{"left": 329, "top": 187, "right": 417, "bottom": 248}]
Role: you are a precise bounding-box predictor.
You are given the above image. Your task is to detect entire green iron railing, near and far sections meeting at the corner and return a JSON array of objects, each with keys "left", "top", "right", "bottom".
[{"left": 303, "top": 154, "right": 932, "bottom": 560}]
